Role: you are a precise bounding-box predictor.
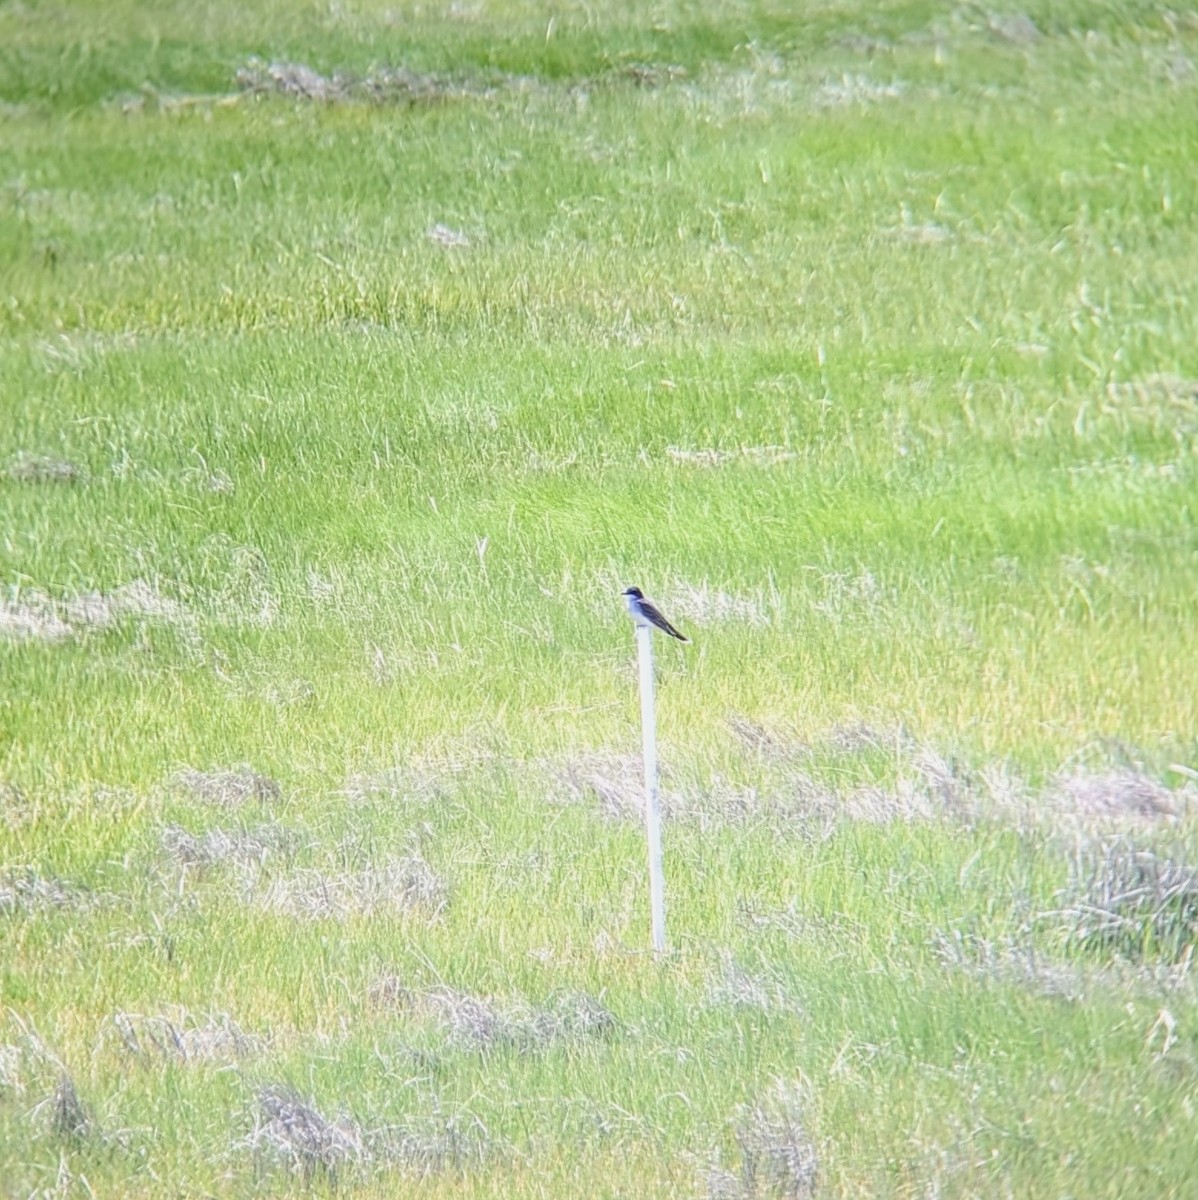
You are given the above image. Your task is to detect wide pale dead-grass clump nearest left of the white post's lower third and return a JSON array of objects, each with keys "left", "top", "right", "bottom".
[{"left": 251, "top": 854, "right": 448, "bottom": 920}]
